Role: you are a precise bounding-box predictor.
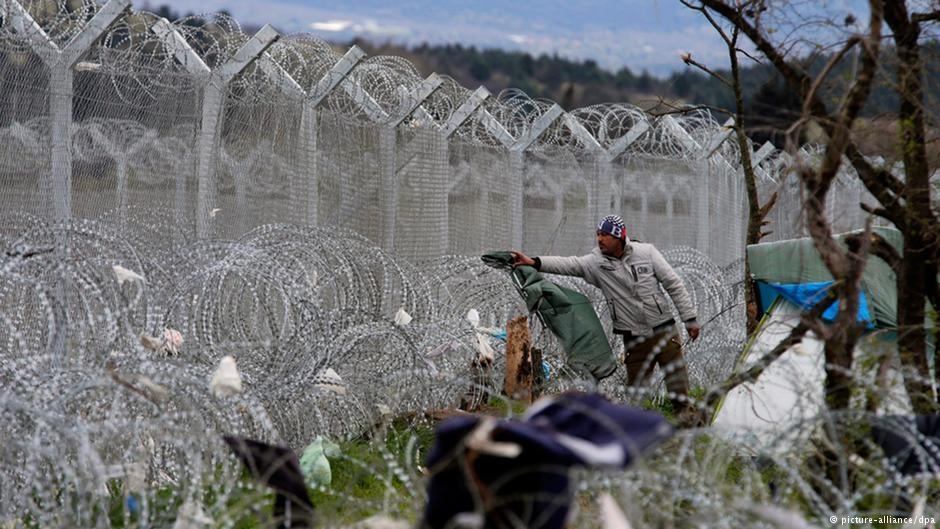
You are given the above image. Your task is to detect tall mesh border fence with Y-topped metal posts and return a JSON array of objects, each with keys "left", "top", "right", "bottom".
[{"left": 0, "top": 0, "right": 888, "bottom": 266}]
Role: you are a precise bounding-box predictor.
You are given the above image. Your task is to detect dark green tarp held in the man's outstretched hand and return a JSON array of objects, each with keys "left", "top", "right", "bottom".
[{"left": 483, "top": 252, "right": 617, "bottom": 380}]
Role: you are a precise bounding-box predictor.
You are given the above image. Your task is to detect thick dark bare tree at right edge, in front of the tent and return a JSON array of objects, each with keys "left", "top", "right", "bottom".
[{"left": 693, "top": 0, "right": 940, "bottom": 413}]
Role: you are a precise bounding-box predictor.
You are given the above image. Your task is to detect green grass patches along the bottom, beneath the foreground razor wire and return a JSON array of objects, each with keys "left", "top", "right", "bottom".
[{"left": 81, "top": 388, "right": 940, "bottom": 529}]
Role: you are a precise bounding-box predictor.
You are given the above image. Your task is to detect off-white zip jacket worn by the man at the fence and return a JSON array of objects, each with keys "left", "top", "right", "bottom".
[{"left": 539, "top": 241, "right": 696, "bottom": 336}]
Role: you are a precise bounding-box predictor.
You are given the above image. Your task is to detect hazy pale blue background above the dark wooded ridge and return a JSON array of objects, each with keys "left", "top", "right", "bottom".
[{"left": 134, "top": 0, "right": 872, "bottom": 77}]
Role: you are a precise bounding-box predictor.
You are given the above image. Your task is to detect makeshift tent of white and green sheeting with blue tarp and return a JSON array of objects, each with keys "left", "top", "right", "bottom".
[{"left": 714, "top": 228, "right": 910, "bottom": 451}]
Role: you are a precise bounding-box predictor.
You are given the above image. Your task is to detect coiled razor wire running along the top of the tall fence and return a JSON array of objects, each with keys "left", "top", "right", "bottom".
[{"left": 5, "top": 0, "right": 740, "bottom": 169}]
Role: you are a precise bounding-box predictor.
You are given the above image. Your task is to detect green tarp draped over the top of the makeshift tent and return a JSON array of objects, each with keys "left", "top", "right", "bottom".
[{"left": 747, "top": 228, "right": 903, "bottom": 328}]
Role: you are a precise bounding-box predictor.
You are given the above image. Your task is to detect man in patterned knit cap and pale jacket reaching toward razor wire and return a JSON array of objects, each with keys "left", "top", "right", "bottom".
[{"left": 512, "top": 215, "right": 701, "bottom": 424}]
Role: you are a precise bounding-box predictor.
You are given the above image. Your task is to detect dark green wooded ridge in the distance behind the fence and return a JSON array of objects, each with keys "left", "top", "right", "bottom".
[{"left": 145, "top": 5, "right": 940, "bottom": 132}]
